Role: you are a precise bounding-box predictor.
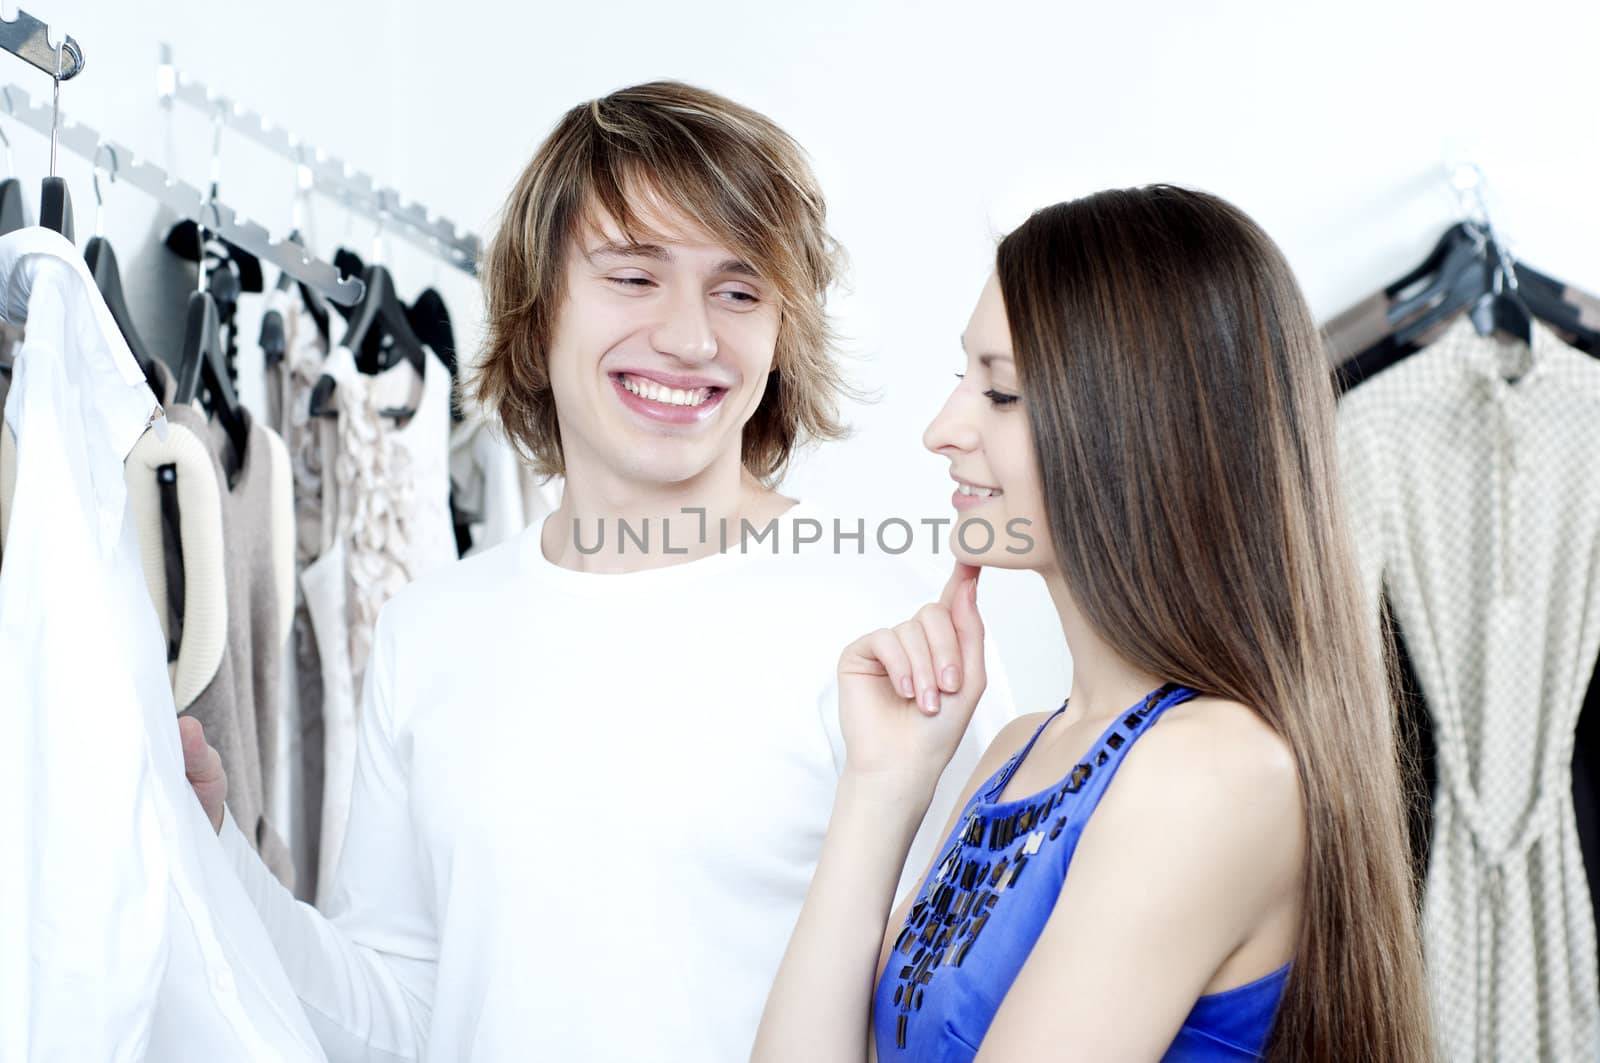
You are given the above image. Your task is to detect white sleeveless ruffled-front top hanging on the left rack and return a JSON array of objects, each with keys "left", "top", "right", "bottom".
[{"left": 301, "top": 347, "right": 456, "bottom": 905}]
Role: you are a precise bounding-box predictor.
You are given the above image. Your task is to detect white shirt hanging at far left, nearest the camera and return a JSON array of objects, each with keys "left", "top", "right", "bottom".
[{"left": 0, "top": 229, "right": 323, "bottom": 1063}]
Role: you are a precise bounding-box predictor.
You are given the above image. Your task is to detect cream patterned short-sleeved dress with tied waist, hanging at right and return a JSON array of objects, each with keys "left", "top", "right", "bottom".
[{"left": 1339, "top": 317, "right": 1600, "bottom": 1061}]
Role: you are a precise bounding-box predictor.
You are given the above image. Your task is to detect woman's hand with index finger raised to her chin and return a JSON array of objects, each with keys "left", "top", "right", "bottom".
[{"left": 838, "top": 562, "right": 987, "bottom": 796}]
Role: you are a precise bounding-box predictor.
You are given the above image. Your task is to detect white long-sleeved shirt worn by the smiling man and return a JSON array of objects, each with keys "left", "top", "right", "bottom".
[{"left": 224, "top": 504, "right": 1014, "bottom": 1063}]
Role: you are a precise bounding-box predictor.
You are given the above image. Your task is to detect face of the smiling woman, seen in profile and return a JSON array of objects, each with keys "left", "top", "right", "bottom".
[{"left": 922, "top": 274, "right": 1054, "bottom": 570}]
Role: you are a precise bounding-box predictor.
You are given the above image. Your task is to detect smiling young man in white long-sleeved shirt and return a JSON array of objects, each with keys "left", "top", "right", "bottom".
[{"left": 189, "top": 83, "right": 1011, "bottom": 1063}]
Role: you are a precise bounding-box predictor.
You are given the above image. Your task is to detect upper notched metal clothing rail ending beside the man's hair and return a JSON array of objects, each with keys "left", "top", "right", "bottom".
[{"left": 157, "top": 45, "right": 483, "bottom": 275}]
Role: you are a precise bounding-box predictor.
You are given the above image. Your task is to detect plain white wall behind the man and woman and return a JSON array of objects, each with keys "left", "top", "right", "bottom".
[{"left": 15, "top": 0, "right": 1600, "bottom": 708}]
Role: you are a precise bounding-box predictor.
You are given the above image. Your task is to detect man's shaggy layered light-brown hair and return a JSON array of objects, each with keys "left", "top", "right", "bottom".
[{"left": 477, "top": 82, "right": 850, "bottom": 483}]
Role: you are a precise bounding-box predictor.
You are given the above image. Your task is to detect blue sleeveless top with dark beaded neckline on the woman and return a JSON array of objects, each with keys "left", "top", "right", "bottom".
[{"left": 872, "top": 685, "right": 1290, "bottom": 1063}]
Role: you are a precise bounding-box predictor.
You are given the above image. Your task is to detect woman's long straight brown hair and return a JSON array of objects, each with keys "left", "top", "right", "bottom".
[{"left": 998, "top": 186, "right": 1434, "bottom": 1063}]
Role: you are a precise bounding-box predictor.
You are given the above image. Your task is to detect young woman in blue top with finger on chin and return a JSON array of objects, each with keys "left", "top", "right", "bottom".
[{"left": 754, "top": 186, "right": 1432, "bottom": 1063}]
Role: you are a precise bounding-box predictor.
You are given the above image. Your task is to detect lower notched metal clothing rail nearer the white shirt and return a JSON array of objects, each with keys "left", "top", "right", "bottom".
[{"left": 0, "top": 84, "right": 365, "bottom": 306}]
